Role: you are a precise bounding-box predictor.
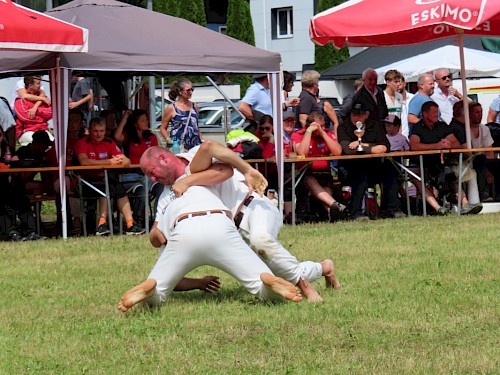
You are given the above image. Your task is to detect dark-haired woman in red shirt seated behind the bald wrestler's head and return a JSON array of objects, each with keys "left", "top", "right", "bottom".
[{"left": 114, "top": 109, "right": 163, "bottom": 227}]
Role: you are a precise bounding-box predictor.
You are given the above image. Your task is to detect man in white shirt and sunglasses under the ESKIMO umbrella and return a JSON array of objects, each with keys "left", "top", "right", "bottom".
[{"left": 431, "top": 68, "right": 471, "bottom": 125}]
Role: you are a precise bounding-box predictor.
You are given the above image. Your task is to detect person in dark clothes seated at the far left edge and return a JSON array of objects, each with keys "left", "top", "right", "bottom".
[{"left": 0, "top": 128, "right": 43, "bottom": 241}]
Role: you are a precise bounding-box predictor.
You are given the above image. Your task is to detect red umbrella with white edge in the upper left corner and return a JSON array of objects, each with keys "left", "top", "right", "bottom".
[{"left": 0, "top": 0, "right": 88, "bottom": 52}]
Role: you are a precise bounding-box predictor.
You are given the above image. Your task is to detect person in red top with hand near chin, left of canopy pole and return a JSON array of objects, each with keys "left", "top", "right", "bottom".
[{"left": 14, "top": 76, "right": 54, "bottom": 146}]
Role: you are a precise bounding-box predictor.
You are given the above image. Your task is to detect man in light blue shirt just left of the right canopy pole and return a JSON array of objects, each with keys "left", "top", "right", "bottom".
[{"left": 238, "top": 73, "right": 273, "bottom": 122}]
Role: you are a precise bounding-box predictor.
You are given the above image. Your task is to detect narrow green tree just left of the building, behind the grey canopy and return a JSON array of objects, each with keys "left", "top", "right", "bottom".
[{"left": 226, "top": 0, "right": 255, "bottom": 96}]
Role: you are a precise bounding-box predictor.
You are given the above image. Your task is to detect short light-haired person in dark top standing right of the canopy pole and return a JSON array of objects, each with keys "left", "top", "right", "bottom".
[{"left": 295, "top": 70, "right": 324, "bottom": 129}]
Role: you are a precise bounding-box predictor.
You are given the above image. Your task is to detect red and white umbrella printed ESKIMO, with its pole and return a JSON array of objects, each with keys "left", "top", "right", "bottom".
[{"left": 309, "top": 0, "right": 500, "bottom": 147}]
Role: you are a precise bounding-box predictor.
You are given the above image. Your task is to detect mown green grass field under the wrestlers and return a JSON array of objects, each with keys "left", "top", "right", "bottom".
[{"left": 0, "top": 214, "right": 500, "bottom": 374}]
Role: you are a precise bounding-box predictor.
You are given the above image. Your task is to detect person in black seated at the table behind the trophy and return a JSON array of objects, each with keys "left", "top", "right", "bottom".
[{"left": 339, "top": 102, "right": 404, "bottom": 221}]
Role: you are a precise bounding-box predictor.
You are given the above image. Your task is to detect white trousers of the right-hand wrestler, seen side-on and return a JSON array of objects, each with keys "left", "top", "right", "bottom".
[{"left": 240, "top": 197, "right": 323, "bottom": 285}]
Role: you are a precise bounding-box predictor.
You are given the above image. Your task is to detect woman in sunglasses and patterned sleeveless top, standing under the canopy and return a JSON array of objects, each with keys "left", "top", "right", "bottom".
[{"left": 160, "top": 78, "right": 202, "bottom": 150}]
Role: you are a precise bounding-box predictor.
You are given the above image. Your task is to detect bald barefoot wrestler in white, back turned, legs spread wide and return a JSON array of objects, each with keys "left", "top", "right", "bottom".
[{"left": 118, "top": 147, "right": 302, "bottom": 312}]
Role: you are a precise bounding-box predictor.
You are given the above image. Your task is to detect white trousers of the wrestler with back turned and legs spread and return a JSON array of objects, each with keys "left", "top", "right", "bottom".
[{"left": 146, "top": 214, "right": 282, "bottom": 305}]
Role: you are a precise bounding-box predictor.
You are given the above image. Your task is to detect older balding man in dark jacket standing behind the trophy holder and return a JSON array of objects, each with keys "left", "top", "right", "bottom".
[{"left": 352, "top": 68, "right": 389, "bottom": 123}]
